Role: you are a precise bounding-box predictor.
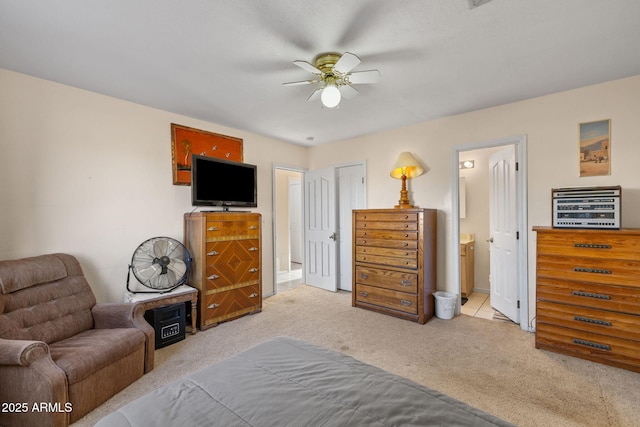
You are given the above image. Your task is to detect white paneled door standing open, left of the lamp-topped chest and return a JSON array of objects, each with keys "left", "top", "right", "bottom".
[{"left": 304, "top": 167, "right": 338, "bottom": 292}]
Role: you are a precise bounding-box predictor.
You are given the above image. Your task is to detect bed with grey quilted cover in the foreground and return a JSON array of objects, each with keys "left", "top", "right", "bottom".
[{"left": 96, "top": 337, "right": 511, "bottom": 427}]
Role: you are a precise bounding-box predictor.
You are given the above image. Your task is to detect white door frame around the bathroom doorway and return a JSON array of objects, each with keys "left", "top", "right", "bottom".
[{"left": 450, "top": 134, "right": 534, "bottom": 332}]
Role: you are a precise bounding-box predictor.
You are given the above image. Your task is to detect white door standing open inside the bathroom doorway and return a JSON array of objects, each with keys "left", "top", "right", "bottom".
[{"left": 489, "top": 145, "right": 519, "bottom": 323}]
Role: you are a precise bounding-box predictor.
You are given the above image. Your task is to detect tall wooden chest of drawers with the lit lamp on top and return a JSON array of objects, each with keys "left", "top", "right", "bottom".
[{"left": 352, "top": 209, "right": 437, "bottom": 324}]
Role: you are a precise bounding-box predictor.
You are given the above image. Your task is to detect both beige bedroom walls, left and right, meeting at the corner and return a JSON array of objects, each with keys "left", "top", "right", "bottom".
[{"left": 5, "top": 70, "right": 640, "bottom": 328}]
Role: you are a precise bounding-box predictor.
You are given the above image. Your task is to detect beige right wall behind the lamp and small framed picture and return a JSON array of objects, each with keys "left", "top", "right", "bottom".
[{"left": 309, "top": 76, "right": 640, "bottom": 328}]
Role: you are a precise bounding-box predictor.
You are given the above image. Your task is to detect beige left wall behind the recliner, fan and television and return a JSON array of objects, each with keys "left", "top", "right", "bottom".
[{"left": 0, "top": 69, "right": 307, "bottom": 301}]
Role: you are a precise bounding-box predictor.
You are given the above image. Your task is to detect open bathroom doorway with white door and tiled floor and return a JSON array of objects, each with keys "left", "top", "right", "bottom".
[{"left": 452, "top": 136, "right": 529, "bottom": 330}]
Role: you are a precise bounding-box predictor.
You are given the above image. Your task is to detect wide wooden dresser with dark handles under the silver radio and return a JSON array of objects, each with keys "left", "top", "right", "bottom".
[{"left": 533, "top": 227, "right": 640, "bottom": 372}]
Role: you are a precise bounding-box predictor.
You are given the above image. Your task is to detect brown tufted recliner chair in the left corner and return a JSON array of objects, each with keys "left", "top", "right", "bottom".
[{"left": 0, "top": 254, "right": 154, "bottom": 426}]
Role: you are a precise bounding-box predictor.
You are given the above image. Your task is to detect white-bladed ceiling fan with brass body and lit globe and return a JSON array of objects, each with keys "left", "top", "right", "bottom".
[{"left": 283, "top": 52, "right": 380, "bottom": 108}]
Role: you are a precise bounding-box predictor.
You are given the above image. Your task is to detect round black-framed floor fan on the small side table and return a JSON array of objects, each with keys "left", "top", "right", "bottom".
[{"left": 127, "top": 237, "right": 191, "bottom": 293}]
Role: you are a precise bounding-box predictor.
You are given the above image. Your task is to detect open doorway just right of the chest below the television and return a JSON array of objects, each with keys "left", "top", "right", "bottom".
[{"left": 273, "top": 166, "right": 304, "bottom": 293}]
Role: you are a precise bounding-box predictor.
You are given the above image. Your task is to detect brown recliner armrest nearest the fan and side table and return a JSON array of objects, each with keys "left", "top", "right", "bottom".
[{"left": 91, "top": 303, "right": 156, "bottom": 373}]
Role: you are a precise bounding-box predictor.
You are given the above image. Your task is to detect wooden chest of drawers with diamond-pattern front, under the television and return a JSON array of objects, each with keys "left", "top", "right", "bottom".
[{"left": 184, "top": 212, "right": 262, "bottom": 329}]
